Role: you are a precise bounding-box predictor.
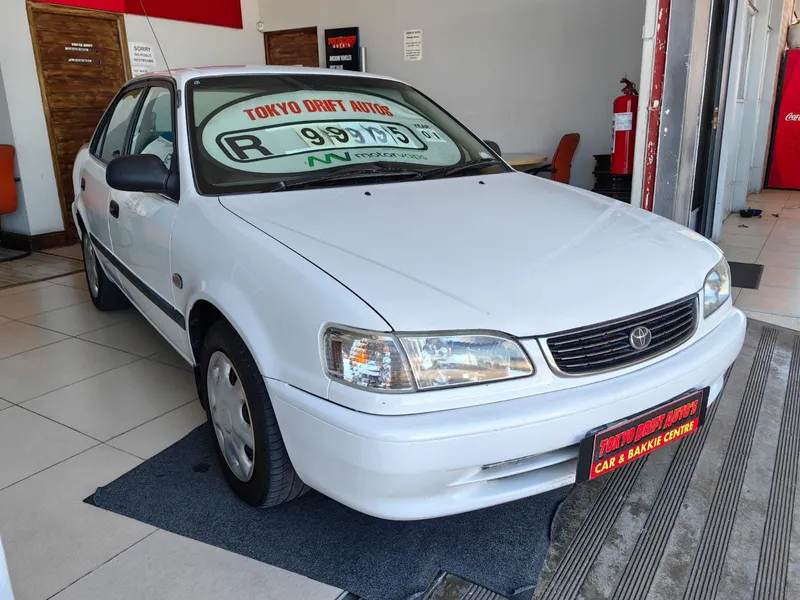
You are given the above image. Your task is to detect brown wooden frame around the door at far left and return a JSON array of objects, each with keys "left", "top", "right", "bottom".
[{"left": 26, "top": 0, "right": 132, "bottom": 244}]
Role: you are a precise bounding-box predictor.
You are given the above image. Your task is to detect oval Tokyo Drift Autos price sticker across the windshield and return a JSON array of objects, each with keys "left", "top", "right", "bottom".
[{"left": 201, "top": 90, "right": 461, "bottom": 173}]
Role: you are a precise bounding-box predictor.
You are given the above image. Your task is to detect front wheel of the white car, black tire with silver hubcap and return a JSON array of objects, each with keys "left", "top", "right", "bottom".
[{"left": 198, "top": 321, "right": 310, "bottom": 508}]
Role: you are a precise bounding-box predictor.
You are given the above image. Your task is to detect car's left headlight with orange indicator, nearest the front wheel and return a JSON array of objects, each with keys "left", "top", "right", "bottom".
[{"left": 323, "top": 327, "right": 533, "bottom": 392}]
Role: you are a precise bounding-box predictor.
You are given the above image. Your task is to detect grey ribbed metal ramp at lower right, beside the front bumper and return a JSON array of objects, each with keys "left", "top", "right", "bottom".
[{"left": 534, "top": 321, "right": 800, "bottom": 600}]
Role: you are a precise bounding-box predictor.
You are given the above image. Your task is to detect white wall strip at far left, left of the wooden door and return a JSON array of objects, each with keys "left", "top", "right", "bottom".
[{"left": 0, "top": 1, "right": 64, "bottom": 235}]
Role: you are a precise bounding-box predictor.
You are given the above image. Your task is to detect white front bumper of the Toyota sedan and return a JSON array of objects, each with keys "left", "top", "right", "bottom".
[{"left": 267, "top": 309, "right": 746, "bottom": 520}]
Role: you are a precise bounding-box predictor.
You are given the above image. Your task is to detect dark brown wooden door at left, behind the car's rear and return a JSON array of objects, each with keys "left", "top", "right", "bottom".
[{"left": 26, "top": 2, "right": 129, "bottom": 243}]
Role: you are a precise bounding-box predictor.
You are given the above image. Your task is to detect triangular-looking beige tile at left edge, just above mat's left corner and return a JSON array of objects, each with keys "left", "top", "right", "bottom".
[{"left": 0, "top": 406, "right": 97, "bottom": 489}]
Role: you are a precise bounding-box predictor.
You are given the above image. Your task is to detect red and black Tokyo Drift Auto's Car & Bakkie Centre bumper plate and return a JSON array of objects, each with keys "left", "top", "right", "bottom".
[{"left": 577, "top": 388, "right": 709, "bottom": 481}]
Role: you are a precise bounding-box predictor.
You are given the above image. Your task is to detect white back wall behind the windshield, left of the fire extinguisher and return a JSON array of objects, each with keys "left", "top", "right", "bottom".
[{"left": 260, "top": 0, "right": 645, "bottom": 188}]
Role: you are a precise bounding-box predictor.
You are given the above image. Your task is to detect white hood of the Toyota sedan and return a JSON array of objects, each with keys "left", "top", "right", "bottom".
[{"left": 220, "top": 173, "right": 721, "bottom": 337}]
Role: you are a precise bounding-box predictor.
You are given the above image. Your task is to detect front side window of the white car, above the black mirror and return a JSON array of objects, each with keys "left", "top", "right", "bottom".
[{"left": 131, "top": 87, "right": 175, "bottom": 169}]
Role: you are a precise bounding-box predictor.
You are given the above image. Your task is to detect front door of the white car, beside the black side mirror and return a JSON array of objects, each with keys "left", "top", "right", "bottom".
[{"left": 109, "top": 80, "right": 186, "bottom": 349}]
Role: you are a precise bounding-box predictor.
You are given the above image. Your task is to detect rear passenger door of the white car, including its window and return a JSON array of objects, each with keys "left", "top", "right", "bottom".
[{"left": 80, "top": 87, "right": 144, "bottom": 270}]
